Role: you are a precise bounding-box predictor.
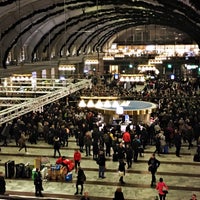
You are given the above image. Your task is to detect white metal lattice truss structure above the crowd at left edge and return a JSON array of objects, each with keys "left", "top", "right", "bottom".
[{"left": 0, "top": 79, "right": 91, "bottom": 125}]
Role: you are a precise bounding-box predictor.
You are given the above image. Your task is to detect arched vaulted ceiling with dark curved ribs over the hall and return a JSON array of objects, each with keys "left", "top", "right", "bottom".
[{"left": 0, "top": 0, "right": 200, "bottom": 68}]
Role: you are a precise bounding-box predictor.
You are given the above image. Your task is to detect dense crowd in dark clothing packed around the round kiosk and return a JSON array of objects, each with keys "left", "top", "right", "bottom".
[{"left": 0, "top": 76, "right": 200, "bottom": 200}]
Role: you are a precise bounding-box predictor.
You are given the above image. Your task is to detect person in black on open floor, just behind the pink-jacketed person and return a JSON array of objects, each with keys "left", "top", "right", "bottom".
[{"left": 148, "top": 153, "right": 160, "bottom": 187}]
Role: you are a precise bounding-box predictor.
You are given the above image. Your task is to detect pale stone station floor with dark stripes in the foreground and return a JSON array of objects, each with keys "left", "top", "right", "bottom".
[{"left": 0, "top": 137, "right": 200, "bottom": 200}]
